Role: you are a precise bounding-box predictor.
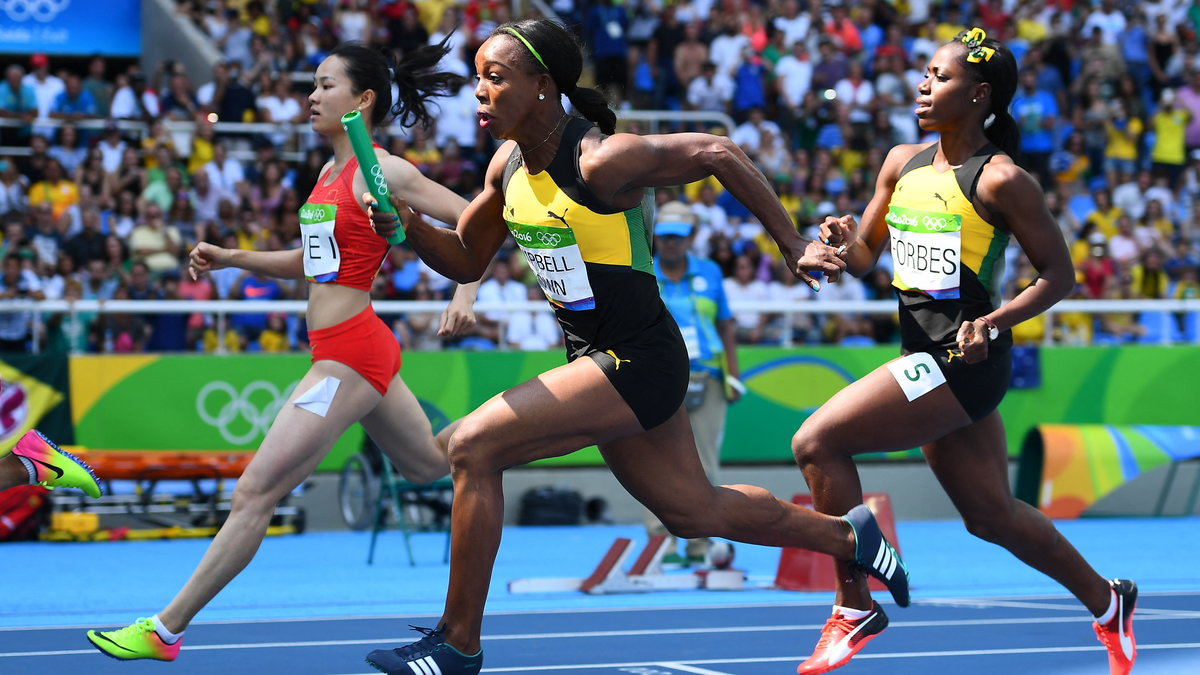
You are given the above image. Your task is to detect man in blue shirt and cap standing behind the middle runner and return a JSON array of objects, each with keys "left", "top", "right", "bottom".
[{"left": 646, "top": 202, "right": 744, "bottom": 563}]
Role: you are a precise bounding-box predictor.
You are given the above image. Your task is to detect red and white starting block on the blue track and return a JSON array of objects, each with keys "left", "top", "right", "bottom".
[{"left": 509, "top": 534, "right": 745, "bottom": 596}]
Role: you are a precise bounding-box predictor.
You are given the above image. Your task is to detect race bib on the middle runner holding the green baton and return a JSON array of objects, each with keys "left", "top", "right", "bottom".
[{"left": 509, "top": 221, "right": 596, "bottom": 310}]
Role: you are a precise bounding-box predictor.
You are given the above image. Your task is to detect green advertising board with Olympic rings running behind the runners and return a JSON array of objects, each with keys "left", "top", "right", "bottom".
[{"left": 71, "top": 346, "right": 1200, "bottom": 471}]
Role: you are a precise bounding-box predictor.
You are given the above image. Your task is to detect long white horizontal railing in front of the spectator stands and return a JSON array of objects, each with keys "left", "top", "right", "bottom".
[{"left": 0, "top": 299, "right": 1200, "bottom": 351}]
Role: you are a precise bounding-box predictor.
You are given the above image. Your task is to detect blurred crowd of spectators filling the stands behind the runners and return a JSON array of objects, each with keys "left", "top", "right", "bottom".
[{"left": 0, "top": 0, "right": 1200, "bottom": 352}]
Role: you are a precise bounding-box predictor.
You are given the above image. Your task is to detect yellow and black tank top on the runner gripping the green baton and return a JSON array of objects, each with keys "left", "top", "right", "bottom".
[{"left": 503, "top": 117, "right": 666, "bottom": 359}]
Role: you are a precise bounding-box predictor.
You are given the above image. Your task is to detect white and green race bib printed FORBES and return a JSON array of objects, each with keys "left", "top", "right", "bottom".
[{"left": 884, "top": 205, "right": 962, "bottom": 298}]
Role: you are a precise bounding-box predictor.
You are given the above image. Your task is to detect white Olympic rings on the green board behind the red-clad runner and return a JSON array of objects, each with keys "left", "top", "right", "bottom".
[{"left": 196, "top": 380, "right": 299, "bottom": 446}]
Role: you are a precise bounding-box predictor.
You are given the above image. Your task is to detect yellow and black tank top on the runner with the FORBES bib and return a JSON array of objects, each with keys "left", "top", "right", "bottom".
[{"left": 884, "top": 143, "right": 1012, "bottom": 351}]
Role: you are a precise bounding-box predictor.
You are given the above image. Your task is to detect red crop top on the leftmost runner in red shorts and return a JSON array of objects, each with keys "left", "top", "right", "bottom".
[{"left": 300, "top": 157, "right": 388, "bottom": 291}]
